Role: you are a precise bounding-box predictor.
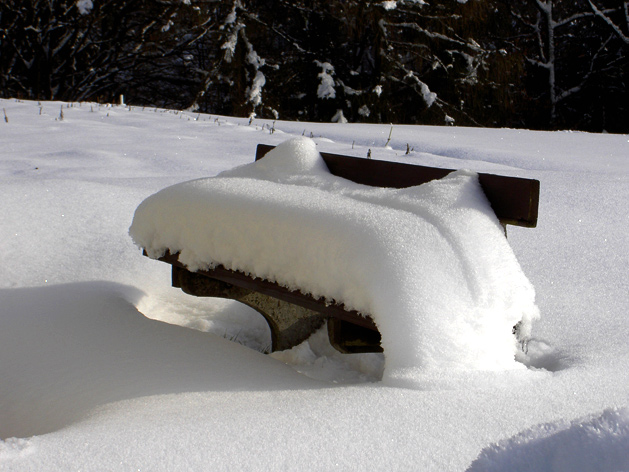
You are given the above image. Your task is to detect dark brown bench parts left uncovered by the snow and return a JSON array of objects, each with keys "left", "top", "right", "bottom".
[{"left": 148, "top": 144, "right": 540, "bottom": 353}]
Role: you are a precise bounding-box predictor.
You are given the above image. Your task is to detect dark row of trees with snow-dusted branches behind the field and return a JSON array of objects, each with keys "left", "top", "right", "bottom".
[{"left": 0, "top": 0, "right": 629, "bottom": 132}]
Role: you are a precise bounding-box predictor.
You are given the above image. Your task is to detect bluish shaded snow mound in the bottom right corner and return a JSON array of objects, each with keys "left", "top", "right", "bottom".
[{"left": 468, "top": 408, "right": 629, "bottom": 472}]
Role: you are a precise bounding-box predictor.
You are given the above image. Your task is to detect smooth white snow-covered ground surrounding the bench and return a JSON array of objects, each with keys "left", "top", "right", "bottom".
[{"left": 0, "top": 100, "right": 629, "bottom": 471}]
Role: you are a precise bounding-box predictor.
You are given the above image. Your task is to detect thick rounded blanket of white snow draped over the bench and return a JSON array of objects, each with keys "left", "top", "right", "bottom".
[{"left": 130, "top": 138, "right": 538, "bottom": 383}]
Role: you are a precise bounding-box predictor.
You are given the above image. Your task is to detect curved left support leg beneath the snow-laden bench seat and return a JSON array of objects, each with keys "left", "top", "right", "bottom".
[{"left": 172, "top": 265, "right": 326, "bottom": 351}]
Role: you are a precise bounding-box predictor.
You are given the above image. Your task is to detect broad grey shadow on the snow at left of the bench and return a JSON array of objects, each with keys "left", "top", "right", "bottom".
[{"left": 0, "top": 282, "right": 327, "bottom": 439}]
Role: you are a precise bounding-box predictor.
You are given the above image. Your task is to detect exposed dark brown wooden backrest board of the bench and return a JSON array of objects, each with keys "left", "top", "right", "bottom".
[{"left": 256, "top": 144, "right": 539, "bottom": 228}]
